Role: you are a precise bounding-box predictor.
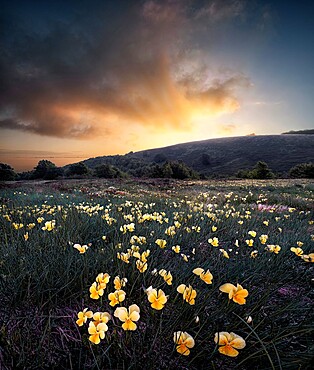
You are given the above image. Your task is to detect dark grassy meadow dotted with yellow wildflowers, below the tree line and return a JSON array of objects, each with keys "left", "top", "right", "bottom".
[{"left": 0, "top": 180, "right": 314, "bottom": 369}]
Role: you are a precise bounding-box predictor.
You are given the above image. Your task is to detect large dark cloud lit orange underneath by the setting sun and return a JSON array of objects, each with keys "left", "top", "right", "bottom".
[{"left": 0, "top": 0, "right": 249, "bottom": 139}]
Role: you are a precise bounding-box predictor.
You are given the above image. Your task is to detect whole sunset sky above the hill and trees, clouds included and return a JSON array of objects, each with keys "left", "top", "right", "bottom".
[{"left": 0, "top": 0, "right": 314, "bottom": 171}]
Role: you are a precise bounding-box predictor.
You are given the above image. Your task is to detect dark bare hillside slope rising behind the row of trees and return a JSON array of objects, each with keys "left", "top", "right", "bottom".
[{"left": 79, "top": 134, "right": 314, "bottom": 176}]
